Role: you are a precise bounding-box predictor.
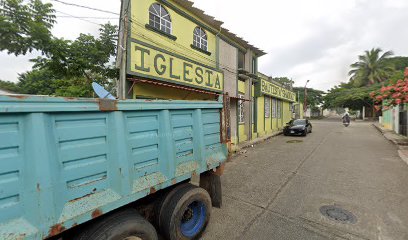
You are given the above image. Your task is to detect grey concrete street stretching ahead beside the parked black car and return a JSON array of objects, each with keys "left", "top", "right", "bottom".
[{"left": 203, "top": 120, "right": 408, "bottom": 240}]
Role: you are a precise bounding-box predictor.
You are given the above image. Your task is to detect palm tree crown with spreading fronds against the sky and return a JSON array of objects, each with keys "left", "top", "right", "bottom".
[{"left": 349, "top": 48, "right": 394, "bottom": 87}]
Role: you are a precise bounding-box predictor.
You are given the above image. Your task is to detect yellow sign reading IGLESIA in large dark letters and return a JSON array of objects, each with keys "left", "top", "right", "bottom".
[{"left": 128, "top": 41, "right": 224, "bottom": 92}]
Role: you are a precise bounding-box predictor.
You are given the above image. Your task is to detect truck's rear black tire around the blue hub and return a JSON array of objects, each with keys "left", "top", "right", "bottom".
[{"left": 161, "top": 186, "right": 211, "bottom": 240}]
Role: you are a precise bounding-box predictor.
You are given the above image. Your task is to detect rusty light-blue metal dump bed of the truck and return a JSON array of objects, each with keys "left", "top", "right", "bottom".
[{"left": 0, "top": 96, "right": 227, "bottom": 240}]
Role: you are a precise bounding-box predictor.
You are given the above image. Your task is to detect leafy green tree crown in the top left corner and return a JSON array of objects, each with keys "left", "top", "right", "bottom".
[{"left": 0, "top": 0, "right": 55, "bottom": 56}]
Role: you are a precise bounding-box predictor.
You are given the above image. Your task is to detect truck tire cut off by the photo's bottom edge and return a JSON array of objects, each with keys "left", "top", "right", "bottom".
[{"left": 75, "top": 209, "right": 158, "bottom": 240}]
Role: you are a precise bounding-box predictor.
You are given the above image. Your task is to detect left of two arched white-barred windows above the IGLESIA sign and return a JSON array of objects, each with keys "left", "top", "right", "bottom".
[{"left": 149, "top": 3, "right": 172, "bottom": 34}]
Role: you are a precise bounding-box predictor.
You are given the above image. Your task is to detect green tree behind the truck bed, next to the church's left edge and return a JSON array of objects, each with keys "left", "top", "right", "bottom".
[{"left": 32, "top": 23, "right": 119, "bottom": 97}]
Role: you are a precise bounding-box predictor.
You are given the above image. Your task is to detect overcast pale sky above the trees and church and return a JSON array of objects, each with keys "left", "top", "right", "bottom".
[{"left": 0, "top": 0, "right": 408, "bottom": 90}]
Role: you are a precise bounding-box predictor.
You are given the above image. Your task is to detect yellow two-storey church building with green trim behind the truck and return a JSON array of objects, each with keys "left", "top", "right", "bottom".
[{"left": 118, "top": 0, "right": 296, "bottom": 151}]
